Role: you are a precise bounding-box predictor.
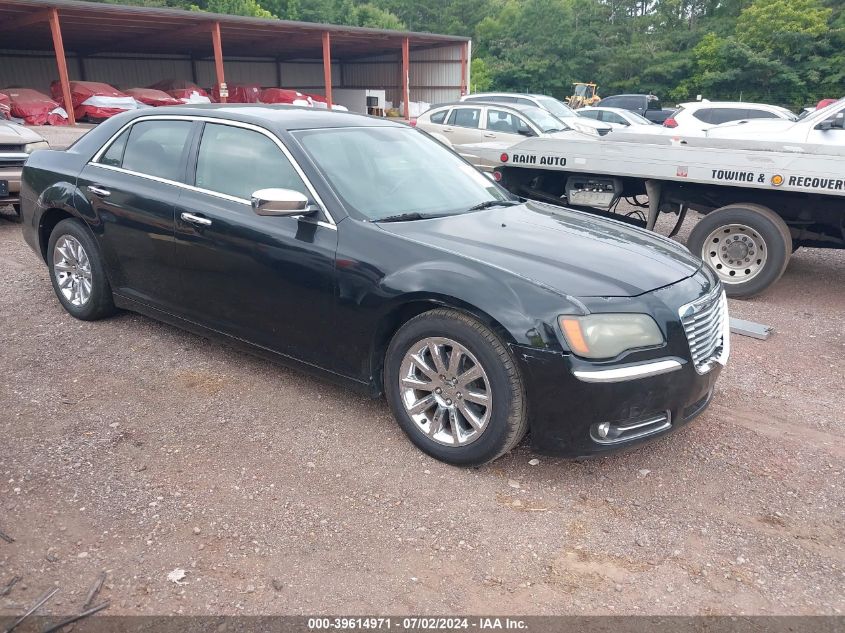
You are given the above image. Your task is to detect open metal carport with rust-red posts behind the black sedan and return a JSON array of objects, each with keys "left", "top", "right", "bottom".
[{"left": 0, "top": 0, "right": 471, "bottom": 122}]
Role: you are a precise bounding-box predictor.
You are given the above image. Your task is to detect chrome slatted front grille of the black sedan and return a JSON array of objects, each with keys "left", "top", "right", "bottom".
[{"left": 679, "top": 287, "right": 730, "bottom": 374}]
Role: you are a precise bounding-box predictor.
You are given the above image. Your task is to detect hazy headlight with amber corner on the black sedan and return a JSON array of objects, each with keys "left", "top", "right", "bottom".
[{"left": 558, "top": 314, "right": 663, "bottom": 358}]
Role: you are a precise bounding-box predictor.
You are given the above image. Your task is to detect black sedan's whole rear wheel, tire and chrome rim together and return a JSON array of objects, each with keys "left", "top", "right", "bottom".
[{"left": 47, "top": 219, "right": 115, "bottom": 321}]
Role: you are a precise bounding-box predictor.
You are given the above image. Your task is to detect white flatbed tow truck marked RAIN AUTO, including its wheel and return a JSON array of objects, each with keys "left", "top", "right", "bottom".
[{"left": 472, "top": 130, "right": 845, "bottom": 297}]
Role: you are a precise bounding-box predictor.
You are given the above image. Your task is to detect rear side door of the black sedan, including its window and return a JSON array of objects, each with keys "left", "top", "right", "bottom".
[{"left": 76, "top": 118, "right": 194, "bottom": 311}]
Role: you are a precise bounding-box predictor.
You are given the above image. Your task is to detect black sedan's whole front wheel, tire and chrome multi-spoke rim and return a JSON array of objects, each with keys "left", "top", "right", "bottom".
[{"left": 384, "top": 309, "right": 528, "bottom": 466}]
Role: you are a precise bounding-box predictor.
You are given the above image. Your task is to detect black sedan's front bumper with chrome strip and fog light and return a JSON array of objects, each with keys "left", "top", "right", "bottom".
[{"left": 514, "top": 270, "right": 730, "bottom": 457}]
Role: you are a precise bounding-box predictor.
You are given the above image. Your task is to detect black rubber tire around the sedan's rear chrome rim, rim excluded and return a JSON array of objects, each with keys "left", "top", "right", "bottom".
[{"left": 47, "top": 219, "right": 116, "bottom": 321}]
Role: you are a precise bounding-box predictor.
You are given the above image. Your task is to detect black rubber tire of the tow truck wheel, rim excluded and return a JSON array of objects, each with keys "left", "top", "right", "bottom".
[{"left": 687, "top": 203, "right": 792, "bottom": 298}]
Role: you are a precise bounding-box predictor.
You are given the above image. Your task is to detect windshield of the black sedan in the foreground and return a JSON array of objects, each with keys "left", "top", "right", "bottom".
[{"left": 294, "top": 127, "right": 512, "bottom": 221}]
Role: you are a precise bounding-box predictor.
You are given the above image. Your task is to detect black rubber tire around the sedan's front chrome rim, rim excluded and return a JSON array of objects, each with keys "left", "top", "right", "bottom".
[{"left": 384, "top": 309, "right": 528, "bottom": 466}]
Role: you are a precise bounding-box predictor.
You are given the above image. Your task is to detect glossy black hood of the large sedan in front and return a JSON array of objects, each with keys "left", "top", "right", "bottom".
[{"left": 379, "top": 202, "right": 701, "bottom": 297}]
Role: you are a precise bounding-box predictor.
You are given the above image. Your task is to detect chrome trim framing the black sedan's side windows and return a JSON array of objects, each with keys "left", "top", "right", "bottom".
[{"left": 88, "top": 114, "right": 337, "bottom": 230}]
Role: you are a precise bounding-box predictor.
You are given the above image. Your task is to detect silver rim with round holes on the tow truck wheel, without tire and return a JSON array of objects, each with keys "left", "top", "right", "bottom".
[{"left": 701, "top": 224, "right": 768, "bottom": 284}]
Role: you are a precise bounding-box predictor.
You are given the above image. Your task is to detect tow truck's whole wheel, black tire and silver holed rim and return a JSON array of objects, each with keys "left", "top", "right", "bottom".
[{"left": 687, "top": 203, "right": 792, "bottom": 297}]
